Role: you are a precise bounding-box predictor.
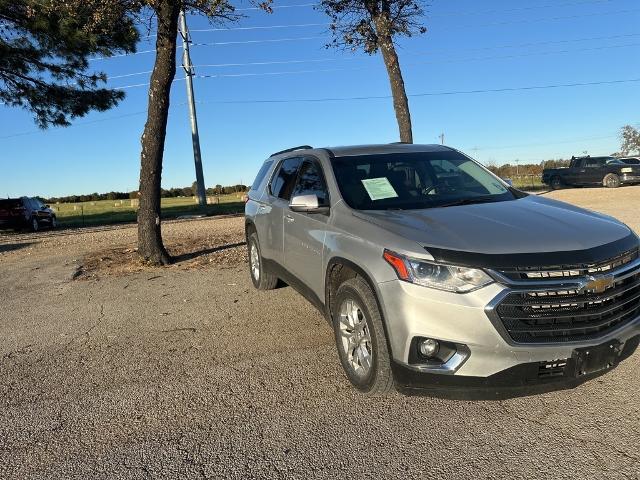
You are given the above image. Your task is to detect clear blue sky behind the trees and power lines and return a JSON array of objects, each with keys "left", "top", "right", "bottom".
[{"left": 0, "top": 0, "right": 640, "bottom": 196}]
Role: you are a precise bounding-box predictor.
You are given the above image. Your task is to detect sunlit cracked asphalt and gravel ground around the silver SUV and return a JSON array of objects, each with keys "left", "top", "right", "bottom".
[{"left": 0, "top": 187, "right": 640, "bottom": 479}]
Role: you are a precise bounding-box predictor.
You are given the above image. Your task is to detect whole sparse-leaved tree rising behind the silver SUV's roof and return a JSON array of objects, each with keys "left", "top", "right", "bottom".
[{"left": 319, "top": 0, "right": 427, "bottom": 143}]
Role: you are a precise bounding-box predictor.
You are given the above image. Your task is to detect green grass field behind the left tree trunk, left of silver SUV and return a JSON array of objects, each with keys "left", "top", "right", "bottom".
[{"left": 51, "top": 193, "right": 244, "bottom": 227}]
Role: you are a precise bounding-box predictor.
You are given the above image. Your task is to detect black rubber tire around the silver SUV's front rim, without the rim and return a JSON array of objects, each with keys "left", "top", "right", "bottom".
[{"left": 332, "top": 277, "right": 393, "bottom": 395}]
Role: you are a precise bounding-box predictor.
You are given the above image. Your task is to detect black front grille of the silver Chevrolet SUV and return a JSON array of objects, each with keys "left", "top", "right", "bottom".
[{"left": 495, "top": 251, "right": 640, "bottom": 343}]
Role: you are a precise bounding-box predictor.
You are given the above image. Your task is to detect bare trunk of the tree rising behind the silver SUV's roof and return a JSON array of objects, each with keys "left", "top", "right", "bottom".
[{"left": 375, "top": 16, "right": 413, "bottom": 143}]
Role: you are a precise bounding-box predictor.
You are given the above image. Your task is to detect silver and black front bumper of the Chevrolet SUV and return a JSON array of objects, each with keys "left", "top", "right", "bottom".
[{"left": 378, "top": 280, "right": 640, "bottom": 396}]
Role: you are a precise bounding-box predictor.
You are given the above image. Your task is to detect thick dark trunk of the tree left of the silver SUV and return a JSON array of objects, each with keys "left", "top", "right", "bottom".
[{"left": 138, "top": 0, "right": 180, "bottom": 265}]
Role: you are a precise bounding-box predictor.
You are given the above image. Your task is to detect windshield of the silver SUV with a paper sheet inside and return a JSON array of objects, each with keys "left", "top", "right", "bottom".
[{"left": 332, "top": 151, "right": 516, "bottom": 210}]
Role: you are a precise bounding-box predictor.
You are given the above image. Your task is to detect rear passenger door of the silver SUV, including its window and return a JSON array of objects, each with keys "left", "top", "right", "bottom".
[{"left": 259, "top": 157, "right": 302, "bottom": 265}]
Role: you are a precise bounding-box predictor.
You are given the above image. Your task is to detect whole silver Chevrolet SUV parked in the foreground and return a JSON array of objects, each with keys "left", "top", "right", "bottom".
[{"left": 245, "top": 144, "right": 640, "bottom": 396}]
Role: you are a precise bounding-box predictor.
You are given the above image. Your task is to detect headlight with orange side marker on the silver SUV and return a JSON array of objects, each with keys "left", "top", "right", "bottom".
[{"left": 383, "top": 250, "right": 493, "bottom": 293}]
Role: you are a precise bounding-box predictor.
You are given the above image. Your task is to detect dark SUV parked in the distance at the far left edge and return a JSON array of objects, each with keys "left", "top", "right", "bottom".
[{"left": 0, "top": 197, "right": 57, "bottom": 232}]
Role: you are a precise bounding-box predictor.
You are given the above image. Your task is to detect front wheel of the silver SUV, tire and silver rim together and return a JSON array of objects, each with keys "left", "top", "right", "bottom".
[{"left": 333, "top": 277, "right": 393, "bottom": 395}]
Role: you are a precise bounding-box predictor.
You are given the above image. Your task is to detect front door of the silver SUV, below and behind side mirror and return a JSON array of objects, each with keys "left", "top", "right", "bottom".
[{"left": 284, "top": 158, "right": 329, "bottom": 299}]
